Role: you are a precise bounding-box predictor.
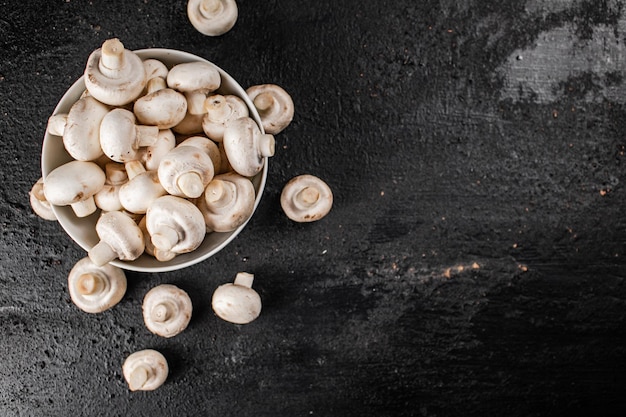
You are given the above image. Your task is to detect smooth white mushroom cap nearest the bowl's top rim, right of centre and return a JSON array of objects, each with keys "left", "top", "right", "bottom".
[{"left": 167, "top": 61, "right": 222, "bottom": 93}]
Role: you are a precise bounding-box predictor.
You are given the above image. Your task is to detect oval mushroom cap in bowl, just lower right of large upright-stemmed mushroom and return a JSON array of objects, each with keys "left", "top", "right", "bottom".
[{"left": 133, "top": 88, "right": 187, "bottom": 129}]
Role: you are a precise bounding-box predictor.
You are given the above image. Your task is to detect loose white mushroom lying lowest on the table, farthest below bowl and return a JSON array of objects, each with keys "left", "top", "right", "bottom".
[{"left": 122, "top": 349, "right": 169, "bottom": 391}]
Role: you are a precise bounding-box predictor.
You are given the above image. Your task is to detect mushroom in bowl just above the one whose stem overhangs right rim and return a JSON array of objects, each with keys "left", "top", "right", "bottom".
[{"left": 202, "top": 94, "right": 250, "bottom": 142}]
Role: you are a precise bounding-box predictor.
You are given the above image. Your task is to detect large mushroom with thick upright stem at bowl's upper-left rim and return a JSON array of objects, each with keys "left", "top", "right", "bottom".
[{"left": 85, "top": 39, "right": 146, "bottom": 106}]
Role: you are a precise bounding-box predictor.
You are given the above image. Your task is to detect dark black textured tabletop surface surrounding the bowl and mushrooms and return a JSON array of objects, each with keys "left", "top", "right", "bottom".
[{"left": 0, "top": 0, "right": 626, "bottom": 417}]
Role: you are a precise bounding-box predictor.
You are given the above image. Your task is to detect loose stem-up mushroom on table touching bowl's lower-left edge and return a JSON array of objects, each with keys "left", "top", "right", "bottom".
[{"left": 67, "top": 257, "right": 126, "bottom": 313}]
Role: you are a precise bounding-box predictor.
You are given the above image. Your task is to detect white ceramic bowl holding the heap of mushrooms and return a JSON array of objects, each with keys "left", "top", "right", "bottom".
[{"left": 41, "top": 48, "right": 268, "bottom": 272}]
